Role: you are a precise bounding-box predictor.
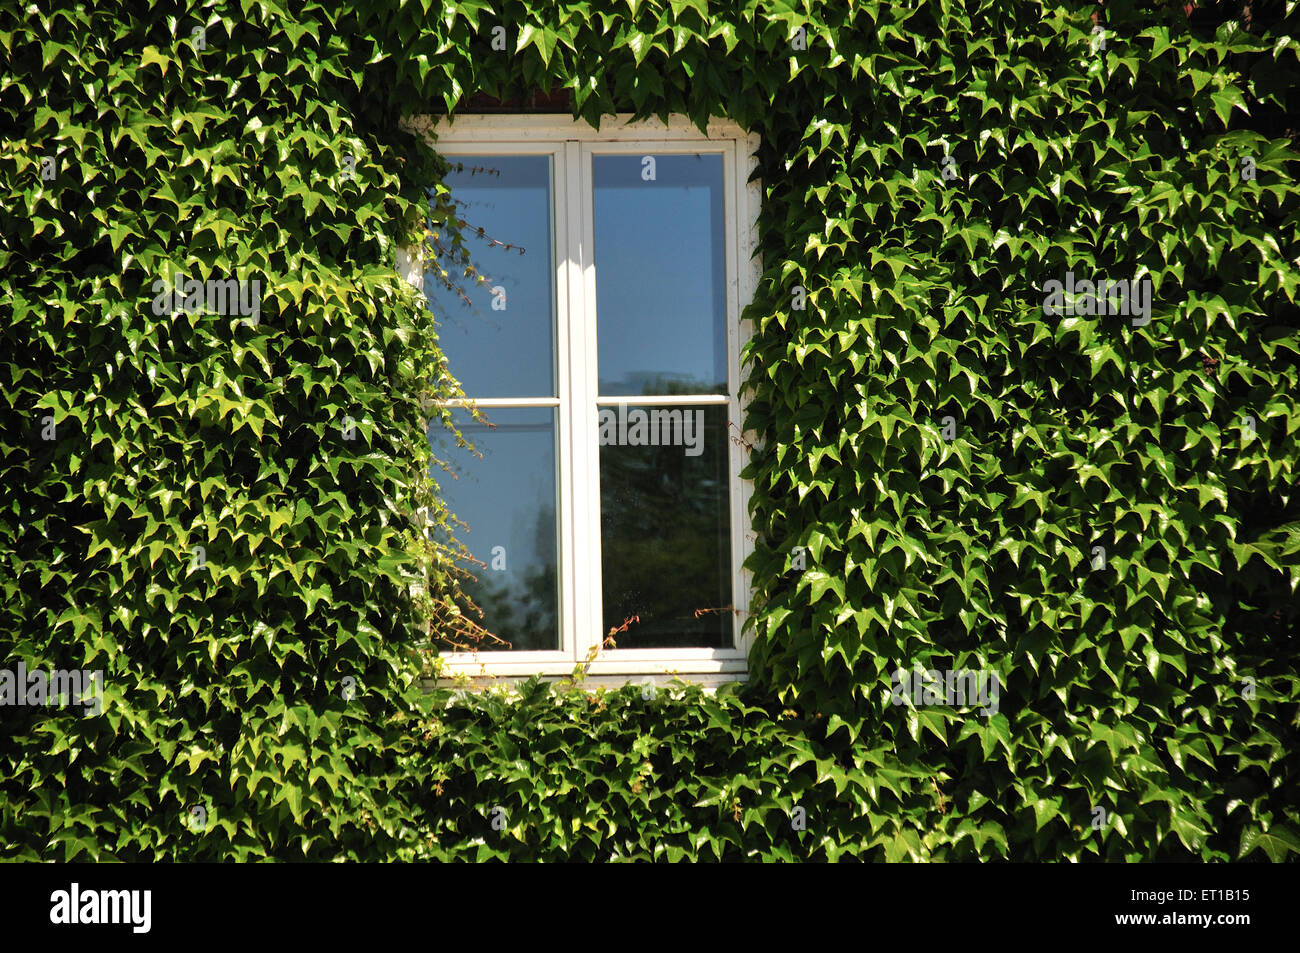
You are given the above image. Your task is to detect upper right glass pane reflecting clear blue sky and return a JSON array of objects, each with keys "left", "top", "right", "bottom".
[{"left": 592, "top": 155, "right": 727, "bottom": 397}]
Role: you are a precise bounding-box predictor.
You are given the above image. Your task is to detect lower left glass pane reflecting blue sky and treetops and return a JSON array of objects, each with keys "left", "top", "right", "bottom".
[{"left": 429, "top": 407, "right": 560, "bottom": 650}]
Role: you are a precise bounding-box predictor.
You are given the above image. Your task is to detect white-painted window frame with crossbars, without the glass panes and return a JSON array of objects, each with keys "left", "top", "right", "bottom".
[{"left": 399, "top": 114, "right": 762, "bottom": 681}]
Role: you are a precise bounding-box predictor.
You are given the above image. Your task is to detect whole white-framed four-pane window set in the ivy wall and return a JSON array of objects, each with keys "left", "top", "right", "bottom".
[{"left": 417, "top": 116, "right": 759, "bottom": 677}]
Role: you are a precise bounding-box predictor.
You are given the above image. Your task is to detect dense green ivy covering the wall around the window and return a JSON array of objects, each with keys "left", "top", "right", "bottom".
[{"left": 0, "top": 0, "right": 1300, "bottom": 859}]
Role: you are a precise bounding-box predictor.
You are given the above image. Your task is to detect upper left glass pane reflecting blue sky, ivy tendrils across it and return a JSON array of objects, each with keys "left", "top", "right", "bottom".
[{"left": 424, "top": 156, "right": 556, "bottom": 398}]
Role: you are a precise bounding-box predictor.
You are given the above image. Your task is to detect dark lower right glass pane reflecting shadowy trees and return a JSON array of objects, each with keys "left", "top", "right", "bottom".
[{"left": 598, "top": 406, "right": 735, "bottom": 649}]
